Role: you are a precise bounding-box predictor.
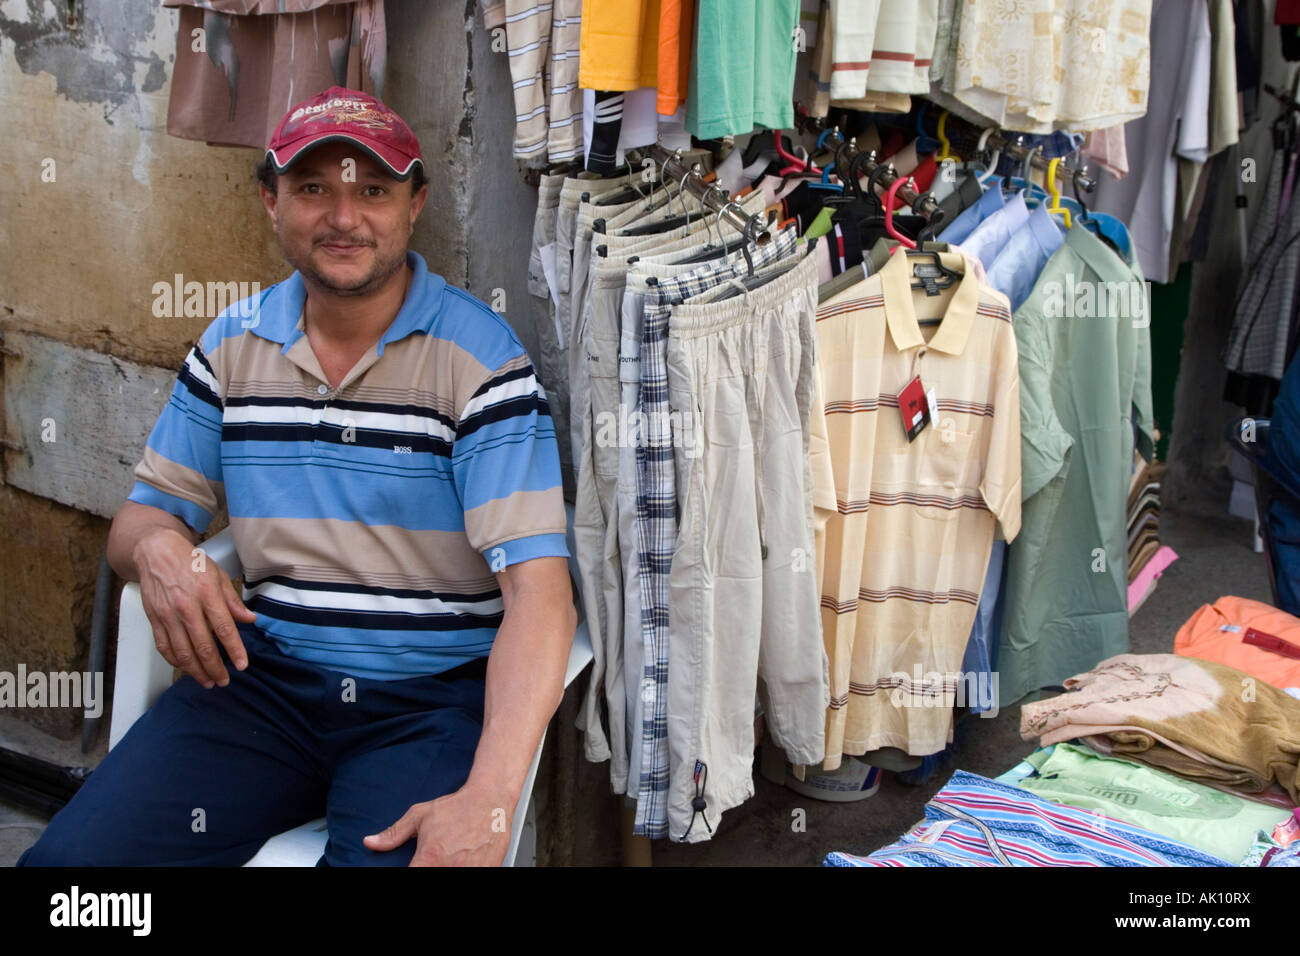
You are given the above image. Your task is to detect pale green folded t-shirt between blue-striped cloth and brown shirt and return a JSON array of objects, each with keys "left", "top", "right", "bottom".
[{"left": 1015, "top": 744, "right": 1291, "bottom": 864}]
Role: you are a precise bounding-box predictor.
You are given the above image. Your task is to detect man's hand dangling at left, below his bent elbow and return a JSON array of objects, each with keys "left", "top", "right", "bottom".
[{"left": 131, "top": 528, "right": 257, "bottom": 688}]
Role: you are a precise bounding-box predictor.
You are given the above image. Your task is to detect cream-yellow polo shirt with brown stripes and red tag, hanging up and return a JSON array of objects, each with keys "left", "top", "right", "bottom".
[{"left": 811, "top": 251, "right": 1021, "bottom": 769}]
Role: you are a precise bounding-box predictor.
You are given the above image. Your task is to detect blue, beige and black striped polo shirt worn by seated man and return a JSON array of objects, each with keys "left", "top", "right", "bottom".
[{"left": 129, "top": 251, "right": 568, "bottom": 680}]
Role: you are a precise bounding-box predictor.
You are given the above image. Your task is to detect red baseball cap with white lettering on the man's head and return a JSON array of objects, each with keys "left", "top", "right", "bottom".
[{"left": 267, "top": 86, "right": 424, "bottom": 182}]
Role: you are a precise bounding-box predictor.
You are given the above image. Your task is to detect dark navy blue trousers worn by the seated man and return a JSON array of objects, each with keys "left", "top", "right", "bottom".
[{"left": 18, "top": 624, "right": 486, "bottom": 866}]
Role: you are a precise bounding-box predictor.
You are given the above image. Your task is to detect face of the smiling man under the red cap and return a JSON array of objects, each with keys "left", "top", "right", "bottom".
[{"left": 261, "top": 143, "right": 429, "bottom": 295}]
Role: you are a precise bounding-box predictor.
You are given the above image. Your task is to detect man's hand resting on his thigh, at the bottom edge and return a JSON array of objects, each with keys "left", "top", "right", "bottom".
[{"left": 364, "top": 787, "right": 515, "bottom": 866}]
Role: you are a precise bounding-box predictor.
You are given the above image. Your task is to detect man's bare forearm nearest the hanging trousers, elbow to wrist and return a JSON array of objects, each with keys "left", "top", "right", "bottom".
[{"left": 465, "top": 558, "right": 577, "bottom": 816}]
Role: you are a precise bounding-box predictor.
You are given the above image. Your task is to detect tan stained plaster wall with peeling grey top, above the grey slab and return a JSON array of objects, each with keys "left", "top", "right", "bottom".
[{"left": 0, "top": 0, "right": 286, "bottom": 368}]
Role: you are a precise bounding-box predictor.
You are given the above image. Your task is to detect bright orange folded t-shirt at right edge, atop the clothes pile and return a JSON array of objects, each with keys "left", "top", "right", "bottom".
[{"left": 1174, "top": 597, "right": 1300, "bottom": 687}]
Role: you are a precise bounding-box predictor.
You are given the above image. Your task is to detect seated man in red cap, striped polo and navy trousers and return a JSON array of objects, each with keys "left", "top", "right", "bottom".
[{"left": 20, "top": 87, "right": 576, "bottom": 866}]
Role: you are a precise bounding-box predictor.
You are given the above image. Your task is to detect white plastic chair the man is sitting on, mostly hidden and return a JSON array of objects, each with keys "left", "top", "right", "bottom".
[{"left": 108, "top": 506, "right": 592, "bottom": 866}]
